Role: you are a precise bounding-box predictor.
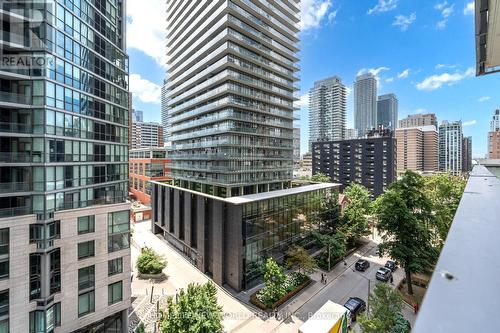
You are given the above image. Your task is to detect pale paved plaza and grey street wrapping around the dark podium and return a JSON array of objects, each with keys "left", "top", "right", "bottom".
[{"left": 130, "top": 222, "right": 415, "bottom": 333}]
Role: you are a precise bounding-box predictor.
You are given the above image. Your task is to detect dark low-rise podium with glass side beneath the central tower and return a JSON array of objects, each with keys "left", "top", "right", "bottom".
[{"left": 151, "top": 182, "right": 338, "bottom": 290}]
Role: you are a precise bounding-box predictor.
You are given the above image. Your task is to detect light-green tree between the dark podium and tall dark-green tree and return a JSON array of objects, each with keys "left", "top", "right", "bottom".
[{"left": 340, "top": 184, "right": 372, "bottom": 241}]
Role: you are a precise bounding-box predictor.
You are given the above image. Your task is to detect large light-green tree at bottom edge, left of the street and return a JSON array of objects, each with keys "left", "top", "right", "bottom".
[{"left": 160, "top": 282, "right": 223, "bottom": 333}]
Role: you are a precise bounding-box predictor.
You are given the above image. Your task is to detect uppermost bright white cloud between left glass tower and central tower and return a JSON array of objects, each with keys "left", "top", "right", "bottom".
[{"left": 127, "top": 0, "right": 166, "bottom": 67}]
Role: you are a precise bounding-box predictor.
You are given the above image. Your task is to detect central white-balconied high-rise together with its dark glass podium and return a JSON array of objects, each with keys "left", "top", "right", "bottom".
[{"left": 151, "top": 0, "right": 336, "bottom": 290}]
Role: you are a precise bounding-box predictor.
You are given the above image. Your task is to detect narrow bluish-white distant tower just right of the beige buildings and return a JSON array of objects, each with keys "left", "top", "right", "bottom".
[{"left": 439, "top": 121, "right": 463, "bottom": 175}]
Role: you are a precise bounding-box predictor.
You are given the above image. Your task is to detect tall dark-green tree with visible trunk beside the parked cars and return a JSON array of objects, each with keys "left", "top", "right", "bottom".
[{"left": 375, "top": 171, "right": 438, "bottom": 295}]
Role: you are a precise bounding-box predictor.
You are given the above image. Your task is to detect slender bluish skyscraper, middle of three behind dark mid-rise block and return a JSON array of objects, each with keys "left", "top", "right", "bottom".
[{"left": 354, "top": 73, "right": 377, "bottom": 136}]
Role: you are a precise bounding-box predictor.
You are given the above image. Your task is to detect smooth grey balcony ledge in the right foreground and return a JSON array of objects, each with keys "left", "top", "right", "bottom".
[{"left": 412, "top": 160, "right": 500, "bottom": 333}]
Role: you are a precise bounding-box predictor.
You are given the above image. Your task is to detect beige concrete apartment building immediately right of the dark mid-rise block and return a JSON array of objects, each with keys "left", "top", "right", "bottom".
[{"left": 396, "top": 125, "right": 438, "bottom": 174}]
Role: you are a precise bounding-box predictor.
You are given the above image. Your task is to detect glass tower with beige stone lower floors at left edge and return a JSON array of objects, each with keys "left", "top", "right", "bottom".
[{"left": 0, "top": 0, "right": 130, "bottom": 333}]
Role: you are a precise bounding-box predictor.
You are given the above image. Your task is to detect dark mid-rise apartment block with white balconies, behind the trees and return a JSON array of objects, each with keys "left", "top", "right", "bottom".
[{"left": 312, "top": 129, "right": 396, "bottom": 196}]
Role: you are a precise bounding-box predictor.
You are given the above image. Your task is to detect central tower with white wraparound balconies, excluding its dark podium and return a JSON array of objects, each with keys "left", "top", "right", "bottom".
[{"left": 166, "top": 0, "right": 299, "bottom": 197}]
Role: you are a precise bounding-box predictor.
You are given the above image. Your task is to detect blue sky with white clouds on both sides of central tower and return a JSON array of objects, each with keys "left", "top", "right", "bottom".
[{"left": 127, "top": 0, "right": 494, "bottom": 157}]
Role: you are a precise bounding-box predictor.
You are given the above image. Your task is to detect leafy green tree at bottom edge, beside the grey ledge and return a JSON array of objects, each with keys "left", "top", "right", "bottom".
[{"left": 359, "top": 283, "right": 409, "bottom": 333}]
